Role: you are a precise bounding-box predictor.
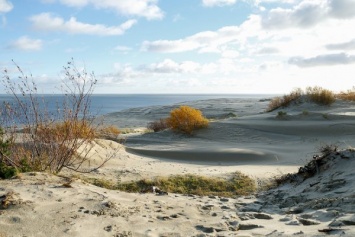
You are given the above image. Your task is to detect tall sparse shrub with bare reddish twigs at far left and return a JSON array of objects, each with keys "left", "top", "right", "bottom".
[{"left": 1, "top": 60, "right": 111, "bottom": 173}]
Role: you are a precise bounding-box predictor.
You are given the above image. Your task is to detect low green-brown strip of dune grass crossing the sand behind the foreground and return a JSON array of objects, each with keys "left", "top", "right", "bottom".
[{"left": 84, "top": 172, "right": 256, "bottom": 197}]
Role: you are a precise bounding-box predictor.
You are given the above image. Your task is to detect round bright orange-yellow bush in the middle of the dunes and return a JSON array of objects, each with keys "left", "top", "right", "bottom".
[{"left": 166, "top": 105, "right": 208, "bottom": 134}]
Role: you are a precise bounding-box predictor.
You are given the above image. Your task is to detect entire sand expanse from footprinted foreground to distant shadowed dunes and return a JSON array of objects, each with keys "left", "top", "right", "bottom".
[{"left": 0, "top": 98, "right": 355, "bottom": 237}]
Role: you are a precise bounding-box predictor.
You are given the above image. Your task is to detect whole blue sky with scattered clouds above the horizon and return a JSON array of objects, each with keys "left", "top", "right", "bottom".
[{"left": 0, "top": 0, "right": 355, "bottom": 94}]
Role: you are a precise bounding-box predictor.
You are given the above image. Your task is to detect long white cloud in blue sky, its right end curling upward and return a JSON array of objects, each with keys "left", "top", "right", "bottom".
[{"left": 30, "top": 13, "right": 137, "bottom": 36}]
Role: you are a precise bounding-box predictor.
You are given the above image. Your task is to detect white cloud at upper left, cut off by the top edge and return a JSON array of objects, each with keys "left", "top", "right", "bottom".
[{"left": 42, "top": 0, "right": 164, "bottom": 20}]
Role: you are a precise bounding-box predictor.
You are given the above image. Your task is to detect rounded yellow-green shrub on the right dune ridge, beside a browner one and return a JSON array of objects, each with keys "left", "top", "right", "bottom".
[{"left": 306, "top": 86, "right": 336, "bottom": 105}]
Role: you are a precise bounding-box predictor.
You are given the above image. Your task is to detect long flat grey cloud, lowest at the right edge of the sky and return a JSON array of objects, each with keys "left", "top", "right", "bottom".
[{"left": 288, "top": 53, "right": 355, "bottom": 67}]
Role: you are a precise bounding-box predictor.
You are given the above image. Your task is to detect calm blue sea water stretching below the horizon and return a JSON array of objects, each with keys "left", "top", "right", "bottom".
[{"left": 0, "top": 94, "right": 270, "bottom": 115}]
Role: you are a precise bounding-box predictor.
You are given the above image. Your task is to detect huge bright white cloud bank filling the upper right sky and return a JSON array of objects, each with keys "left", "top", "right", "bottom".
[{"left": 142, "top": 0, "right": 355, "bottom": 75}]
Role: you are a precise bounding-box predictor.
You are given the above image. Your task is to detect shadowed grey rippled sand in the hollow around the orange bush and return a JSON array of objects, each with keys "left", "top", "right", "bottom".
[{"left": 106, "top": 98, "right": 355, "bottom": 178}]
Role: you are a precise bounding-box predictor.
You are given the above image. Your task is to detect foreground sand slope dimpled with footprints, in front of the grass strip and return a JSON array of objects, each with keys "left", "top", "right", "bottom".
[{"left": 0, "top": 151, "right": 355, "bottom": 236}]
